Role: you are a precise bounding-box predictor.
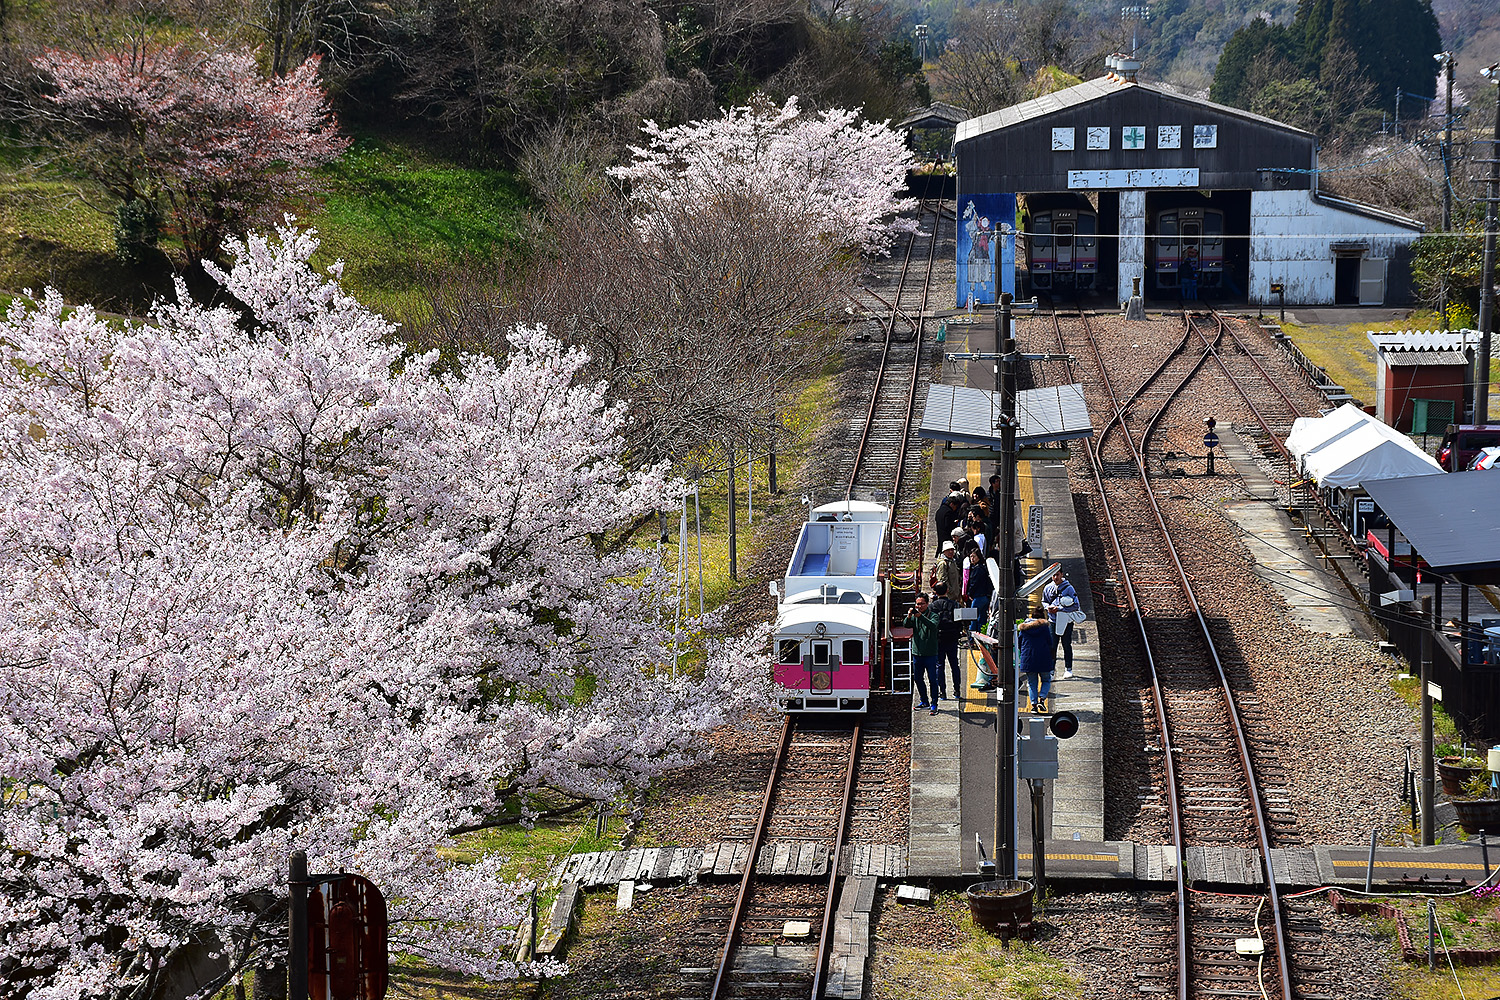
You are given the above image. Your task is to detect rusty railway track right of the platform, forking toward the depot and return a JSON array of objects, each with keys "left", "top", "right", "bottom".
[{"left": 1055, "top": 313, "right": 1298, "bottom": 1000}]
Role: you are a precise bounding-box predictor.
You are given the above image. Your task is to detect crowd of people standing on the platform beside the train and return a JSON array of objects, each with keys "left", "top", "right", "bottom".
[{"left": 903, "top": 475, "right": 1082, "bottom": 715}]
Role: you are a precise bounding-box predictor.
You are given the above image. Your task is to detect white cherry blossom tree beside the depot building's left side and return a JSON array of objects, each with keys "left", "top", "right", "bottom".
[{"left": 611, "top": 97, "right": 915, "bottom": 253}]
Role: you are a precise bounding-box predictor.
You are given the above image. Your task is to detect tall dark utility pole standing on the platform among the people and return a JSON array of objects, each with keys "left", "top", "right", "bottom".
[{"left": 995, "top": 292, "right": 1019, "bottom": 879}]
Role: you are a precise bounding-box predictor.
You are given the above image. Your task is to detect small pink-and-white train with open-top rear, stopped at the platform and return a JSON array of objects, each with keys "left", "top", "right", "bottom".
[{"left": 771, "top": 501, "right": 891, "bottom": 712}]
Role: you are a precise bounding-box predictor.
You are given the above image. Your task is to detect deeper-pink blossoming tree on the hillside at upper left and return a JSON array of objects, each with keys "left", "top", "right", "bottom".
[{"left": 32, "top": 40, "right": 348, "bottom": 264}]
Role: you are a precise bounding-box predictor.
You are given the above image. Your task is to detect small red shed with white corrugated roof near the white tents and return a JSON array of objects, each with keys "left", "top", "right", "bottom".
[{"left": 1365, "top": 330, "right": 1479, "bottom": 435}]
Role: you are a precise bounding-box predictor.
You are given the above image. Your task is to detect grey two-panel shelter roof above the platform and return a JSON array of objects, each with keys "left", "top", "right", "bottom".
[{"left": 917, "top": 382, "right": 1094, "bottom": 448}]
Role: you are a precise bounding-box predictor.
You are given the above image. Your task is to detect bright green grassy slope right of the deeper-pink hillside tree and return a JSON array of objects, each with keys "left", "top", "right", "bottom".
[{"left": 308, "top": 138, "right": 530, "bottom": 319}]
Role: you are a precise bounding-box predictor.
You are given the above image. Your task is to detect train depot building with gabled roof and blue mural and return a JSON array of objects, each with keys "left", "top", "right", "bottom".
[{"left": 954, "top": 55, "right": 1422, "bottom": 306}]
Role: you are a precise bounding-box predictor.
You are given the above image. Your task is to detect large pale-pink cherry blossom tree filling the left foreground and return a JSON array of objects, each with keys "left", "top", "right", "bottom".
[{"left": 0, "top": 220, "right": 767, "bottom": 1000}]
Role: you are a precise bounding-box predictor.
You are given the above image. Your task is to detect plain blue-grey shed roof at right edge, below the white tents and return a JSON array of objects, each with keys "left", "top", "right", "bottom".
[{"left": 1365, "top": 471, "right": 1500, "bottom": 573}]
